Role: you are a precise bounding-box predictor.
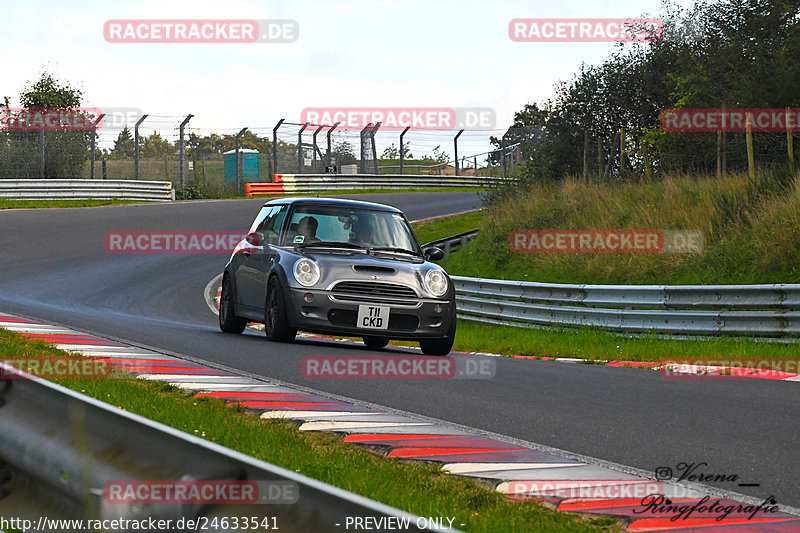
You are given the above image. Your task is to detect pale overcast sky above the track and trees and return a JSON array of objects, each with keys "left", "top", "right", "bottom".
[{"left": 0, "top": 0, "right": 676, "bottom": 153}]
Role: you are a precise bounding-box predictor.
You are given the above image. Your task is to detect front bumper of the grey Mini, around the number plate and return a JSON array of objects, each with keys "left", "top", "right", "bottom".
[{"left": 287, "top": 289, "right": 456, "bottom": 340}]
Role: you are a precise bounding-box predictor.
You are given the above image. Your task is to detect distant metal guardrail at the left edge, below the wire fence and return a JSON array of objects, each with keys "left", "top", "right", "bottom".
[{"left": 0, "top": 179, "right": 175, "bottom": 202}]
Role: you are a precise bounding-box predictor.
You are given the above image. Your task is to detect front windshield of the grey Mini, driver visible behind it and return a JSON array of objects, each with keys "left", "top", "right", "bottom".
[{"left": 282, "top": 205, "right": 420, "bottom": 255}]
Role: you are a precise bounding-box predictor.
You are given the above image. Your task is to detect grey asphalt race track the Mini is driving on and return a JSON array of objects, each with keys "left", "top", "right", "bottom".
[{"left": 0, "top": 193, "right": 800, "bottom": 507}]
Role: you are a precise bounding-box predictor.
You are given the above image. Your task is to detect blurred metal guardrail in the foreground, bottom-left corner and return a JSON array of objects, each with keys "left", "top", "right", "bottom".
[{"left": 0, "top": 363, "right": 454, "bottom": 532}]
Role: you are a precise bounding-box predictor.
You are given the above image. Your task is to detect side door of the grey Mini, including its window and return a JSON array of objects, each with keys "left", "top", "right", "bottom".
[{"left": 239, "top": 205, "right": 289, "bottom": 311}]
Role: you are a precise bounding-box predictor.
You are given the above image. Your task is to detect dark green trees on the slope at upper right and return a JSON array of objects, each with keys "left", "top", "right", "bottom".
[{"left": 500, "top": 0, "right": 800, "bottom": 180}]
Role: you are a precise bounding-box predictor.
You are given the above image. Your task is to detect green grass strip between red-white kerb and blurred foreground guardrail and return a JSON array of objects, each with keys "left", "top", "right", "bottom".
[{"left": 0, "top": 329, "right": 622, "bottom": 533}]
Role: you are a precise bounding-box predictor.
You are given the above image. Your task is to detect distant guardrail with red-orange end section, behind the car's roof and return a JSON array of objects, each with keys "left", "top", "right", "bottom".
[{"left": 245, "top": 174, "right": 513, "bottom": 197}]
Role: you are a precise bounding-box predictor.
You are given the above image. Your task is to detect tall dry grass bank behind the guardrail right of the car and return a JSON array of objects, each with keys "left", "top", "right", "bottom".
[{"left": 442, "top": 169, "right": 800, "bottom": 284}]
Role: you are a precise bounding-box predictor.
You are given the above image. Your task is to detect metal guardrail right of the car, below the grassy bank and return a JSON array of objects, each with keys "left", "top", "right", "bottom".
[{"left": 451, "top": 276, "right": 800, "bottom": 337}]
